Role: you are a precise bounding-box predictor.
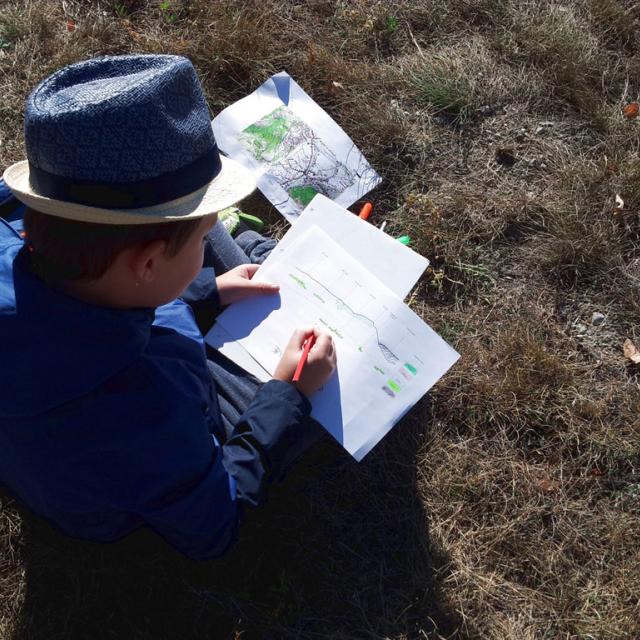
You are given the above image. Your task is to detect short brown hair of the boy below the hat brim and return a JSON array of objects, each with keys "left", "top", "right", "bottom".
[{"left": 24, "top": 208, "right": 202, "bottom": 282}]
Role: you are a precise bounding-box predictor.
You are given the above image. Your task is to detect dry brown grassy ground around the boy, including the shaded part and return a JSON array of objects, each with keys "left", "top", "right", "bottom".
[{"left": 0, "top": 0, "right": 640, "bottom": 640}]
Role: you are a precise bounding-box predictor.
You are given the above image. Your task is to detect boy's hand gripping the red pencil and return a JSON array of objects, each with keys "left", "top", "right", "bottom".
[{"left": 273, "top": 329, "right": 336, "bottom": 396}]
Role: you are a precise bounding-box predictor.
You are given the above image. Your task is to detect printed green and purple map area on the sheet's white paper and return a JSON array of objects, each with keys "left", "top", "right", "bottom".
[{"left": 238, "top": 106, "right": 380, "bottom": 213}]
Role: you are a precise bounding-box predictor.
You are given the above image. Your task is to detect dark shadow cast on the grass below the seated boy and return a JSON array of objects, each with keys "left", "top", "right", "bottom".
[{"left": 12, "top": 408, "right": 460, "bottom": 640}]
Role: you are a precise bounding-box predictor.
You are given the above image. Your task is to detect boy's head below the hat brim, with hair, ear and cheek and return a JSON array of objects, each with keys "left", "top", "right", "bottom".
[{"left": 24, "top": 209, "right": 217, "bottom": 307}]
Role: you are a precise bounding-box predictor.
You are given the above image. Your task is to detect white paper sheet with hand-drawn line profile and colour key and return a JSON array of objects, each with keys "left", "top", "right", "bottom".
[{"left": 212, "top": 227, "right": 459, "bottom": 460}]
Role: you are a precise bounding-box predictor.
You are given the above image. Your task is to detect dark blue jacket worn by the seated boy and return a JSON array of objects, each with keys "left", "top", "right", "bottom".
[{"left": 0, "top": 220, "right": 317, "bottom": 557}]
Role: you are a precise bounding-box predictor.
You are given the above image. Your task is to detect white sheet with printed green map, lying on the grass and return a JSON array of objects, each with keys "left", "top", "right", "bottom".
[{"left": 212, "top": 71, "right": 380, "bottom": 222}]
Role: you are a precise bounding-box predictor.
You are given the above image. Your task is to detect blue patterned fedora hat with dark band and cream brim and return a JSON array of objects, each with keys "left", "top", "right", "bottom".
[{"left": 3, "top": 55, "right": 255, "bottom": 224}]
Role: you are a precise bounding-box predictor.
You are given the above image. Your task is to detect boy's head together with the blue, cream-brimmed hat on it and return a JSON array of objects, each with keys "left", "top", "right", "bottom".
[{"left": 4, "top": 55, "right": 255, "bottom": 306}]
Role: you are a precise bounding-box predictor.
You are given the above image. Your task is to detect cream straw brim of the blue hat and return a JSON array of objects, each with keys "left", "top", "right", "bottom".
[{"left": 3, "top": 155, "right": 256, "bottom": 224}]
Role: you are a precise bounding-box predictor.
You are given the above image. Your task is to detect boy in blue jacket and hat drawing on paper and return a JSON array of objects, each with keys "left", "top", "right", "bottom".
[{"left": 0, "top": 55, "right": 335, "bottom": 557}]
